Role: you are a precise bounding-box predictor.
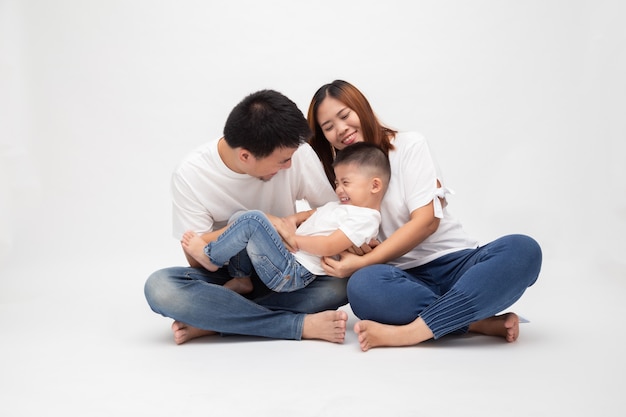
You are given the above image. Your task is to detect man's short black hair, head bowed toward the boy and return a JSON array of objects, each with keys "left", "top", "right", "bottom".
[{"left": 224, "top": 90, "right": 312, "bottom": 158}]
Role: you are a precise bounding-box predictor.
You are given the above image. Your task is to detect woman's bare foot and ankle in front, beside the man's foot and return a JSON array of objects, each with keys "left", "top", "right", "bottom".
[{"left": 354, "top": 317, "right": 433, "bottom": 352}]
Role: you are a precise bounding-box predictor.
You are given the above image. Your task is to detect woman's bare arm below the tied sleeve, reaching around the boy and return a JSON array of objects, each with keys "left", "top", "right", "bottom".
[{"left": 322, "top": 202, "right": 440, "bottom": 277}]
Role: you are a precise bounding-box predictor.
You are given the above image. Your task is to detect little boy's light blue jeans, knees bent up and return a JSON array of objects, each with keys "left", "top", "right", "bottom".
[{"left": 204, "top": 210, "right": 315, "bottom": 292}]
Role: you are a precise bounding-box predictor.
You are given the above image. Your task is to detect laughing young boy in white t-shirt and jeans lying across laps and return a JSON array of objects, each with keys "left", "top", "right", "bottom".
[{"left": 182, "top": 142, "right": 391, "bottom": 294}]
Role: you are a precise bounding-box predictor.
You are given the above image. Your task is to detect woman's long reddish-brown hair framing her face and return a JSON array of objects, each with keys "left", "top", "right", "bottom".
[{"left": 307, "top": 80, "right": 398, "bottom": 187}]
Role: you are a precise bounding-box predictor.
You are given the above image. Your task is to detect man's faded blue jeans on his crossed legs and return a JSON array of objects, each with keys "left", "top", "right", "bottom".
[{"left": 144, "top": 267, "right": 348, "bottom": 340}]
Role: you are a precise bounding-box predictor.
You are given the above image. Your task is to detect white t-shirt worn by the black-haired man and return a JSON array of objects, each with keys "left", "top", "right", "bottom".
[{"left": 171, "top": 139, "right": 337, "bottom": 239}]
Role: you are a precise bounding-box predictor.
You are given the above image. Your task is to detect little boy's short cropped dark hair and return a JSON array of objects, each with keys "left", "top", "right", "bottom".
[{"left": 333, "top": 142, "right": 391, "bottom": 186}]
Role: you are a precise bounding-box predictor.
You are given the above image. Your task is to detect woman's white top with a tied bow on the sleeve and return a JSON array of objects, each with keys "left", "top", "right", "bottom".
[{"left": 379, "top": 132, "right": 478, "bottom": 269}]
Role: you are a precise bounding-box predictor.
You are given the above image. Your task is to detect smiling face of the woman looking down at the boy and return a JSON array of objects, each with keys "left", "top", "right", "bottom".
[{"left": 317, "top": 96, "right": 363, "bottom": 150}]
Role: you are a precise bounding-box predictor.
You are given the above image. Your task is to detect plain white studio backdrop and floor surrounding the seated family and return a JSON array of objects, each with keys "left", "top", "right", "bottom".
[{"left": 0, "top": 0, "right": 626, "bottom": 417}]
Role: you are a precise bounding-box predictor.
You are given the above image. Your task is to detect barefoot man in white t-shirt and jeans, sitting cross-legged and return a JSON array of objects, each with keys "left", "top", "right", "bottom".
[{"left": 144, "top": 90, "right": 348, "bottom": 344}]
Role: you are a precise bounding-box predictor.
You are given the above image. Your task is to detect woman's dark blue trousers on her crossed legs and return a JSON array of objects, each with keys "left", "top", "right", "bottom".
[{"left": 348, "top": 235, "right": 542, "bottom": 339}]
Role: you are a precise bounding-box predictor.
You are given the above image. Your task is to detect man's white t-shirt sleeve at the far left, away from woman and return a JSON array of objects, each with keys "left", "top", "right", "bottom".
[{"left": 171, "top": 172, "right": 213, "bottom": 239}]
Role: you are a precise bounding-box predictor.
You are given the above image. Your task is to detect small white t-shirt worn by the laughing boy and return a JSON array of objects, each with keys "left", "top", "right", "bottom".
[{"left": 294, "top": 202, "right": 380, "bottom": 275}]
